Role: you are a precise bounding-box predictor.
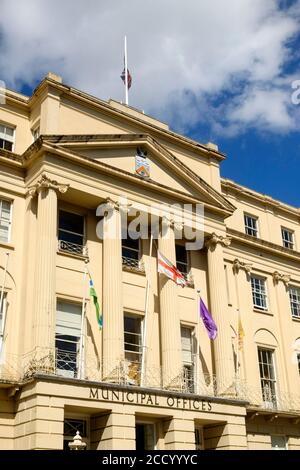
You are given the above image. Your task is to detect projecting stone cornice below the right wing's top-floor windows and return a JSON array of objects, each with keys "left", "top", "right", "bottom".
[{"left": 227, "top": 228, "right": 300, "bottom": 262}]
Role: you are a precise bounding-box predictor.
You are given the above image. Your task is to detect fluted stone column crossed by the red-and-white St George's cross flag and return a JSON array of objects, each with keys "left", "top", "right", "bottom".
[{"left": 158, "top": 218, "right": 182, "bottom": 389}]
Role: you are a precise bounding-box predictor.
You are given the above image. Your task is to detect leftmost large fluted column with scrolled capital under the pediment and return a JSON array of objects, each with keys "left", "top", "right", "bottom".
[{"left": 29, "top": 174, "right": 68, "bottom": 357}]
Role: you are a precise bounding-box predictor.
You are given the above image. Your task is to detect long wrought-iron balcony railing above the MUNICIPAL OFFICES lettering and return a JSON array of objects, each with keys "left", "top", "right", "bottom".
[{"left": 0, "top": 348, "right": 300, "bottom": 417}]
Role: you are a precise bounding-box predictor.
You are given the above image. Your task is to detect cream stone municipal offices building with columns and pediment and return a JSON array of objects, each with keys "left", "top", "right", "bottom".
[{"left": 0, "top": 74, "right": 300, "bottom": 450}]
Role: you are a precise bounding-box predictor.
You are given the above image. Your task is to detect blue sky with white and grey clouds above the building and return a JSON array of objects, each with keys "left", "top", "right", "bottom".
[{"left": 0, "top": 0, "right": 300, "bottom": 207}]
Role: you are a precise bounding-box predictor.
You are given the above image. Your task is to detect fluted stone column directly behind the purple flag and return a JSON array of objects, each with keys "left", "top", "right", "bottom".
[{"left": 206, "top": 233, "right": 235, "bottom": 395}]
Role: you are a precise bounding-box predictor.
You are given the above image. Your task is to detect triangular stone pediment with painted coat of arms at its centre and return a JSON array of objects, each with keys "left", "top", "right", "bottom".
[{"left": 38, "top": 134, "right": 234, "bottom": 212}]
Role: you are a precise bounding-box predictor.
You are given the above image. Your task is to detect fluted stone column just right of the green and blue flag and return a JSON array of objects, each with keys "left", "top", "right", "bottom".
[{"left": 103, "top": 199, "right": 124, "bottom": 382}]
